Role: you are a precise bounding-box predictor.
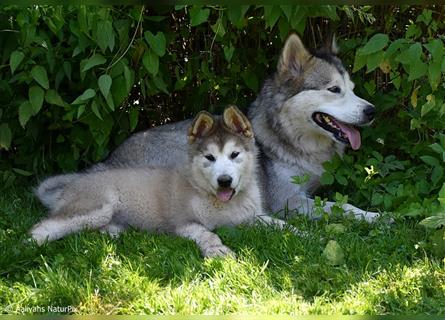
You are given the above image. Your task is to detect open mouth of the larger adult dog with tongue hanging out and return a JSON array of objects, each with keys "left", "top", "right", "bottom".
[{"left": 312, "top": 112, "right": 361, "bottom": 150}]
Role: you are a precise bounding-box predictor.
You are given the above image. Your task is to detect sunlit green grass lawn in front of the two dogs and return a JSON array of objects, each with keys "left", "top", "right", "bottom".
[{"left": 0, "top": 188, "right": 445, "bottom": 314}]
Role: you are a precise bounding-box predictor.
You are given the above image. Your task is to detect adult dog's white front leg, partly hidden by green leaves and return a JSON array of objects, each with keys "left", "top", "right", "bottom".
[{"left": 288, "top": 195, "right": 380, "bottom": 222}]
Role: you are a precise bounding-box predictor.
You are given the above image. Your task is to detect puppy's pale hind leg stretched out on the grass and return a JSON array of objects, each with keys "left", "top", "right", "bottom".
[{"left": 30, "top": 204, "right": 113, "bottom": 245}]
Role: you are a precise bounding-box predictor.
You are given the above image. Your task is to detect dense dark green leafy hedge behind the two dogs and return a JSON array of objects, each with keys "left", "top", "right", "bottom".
[{"left": 0, "top": 5, "right": 445, "bottom": 245}]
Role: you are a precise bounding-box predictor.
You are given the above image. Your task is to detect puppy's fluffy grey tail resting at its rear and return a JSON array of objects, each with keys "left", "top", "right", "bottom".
[{"left": 34, "top": 174, "right": 80, "bottom": 210}]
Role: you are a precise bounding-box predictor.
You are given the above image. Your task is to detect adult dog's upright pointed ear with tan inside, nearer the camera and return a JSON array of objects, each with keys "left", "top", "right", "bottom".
[{"left": 277, "top": 33, "right": 311, "bottom": 74}]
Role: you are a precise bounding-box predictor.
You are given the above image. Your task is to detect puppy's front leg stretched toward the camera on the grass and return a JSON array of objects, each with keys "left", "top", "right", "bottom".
[{"left": 175, "top": 223, "right": 235, "bottom": 257}]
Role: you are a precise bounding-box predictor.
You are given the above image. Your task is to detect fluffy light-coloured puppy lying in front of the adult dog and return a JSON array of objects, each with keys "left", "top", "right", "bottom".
[{"left": 31, "top": 106, "right": 294, "bottom": 257}]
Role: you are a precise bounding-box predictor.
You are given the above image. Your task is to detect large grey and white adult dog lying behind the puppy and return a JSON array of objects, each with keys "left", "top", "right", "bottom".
[{"left": 46, "top": 35, "right": 378, "bottom": 221}]
